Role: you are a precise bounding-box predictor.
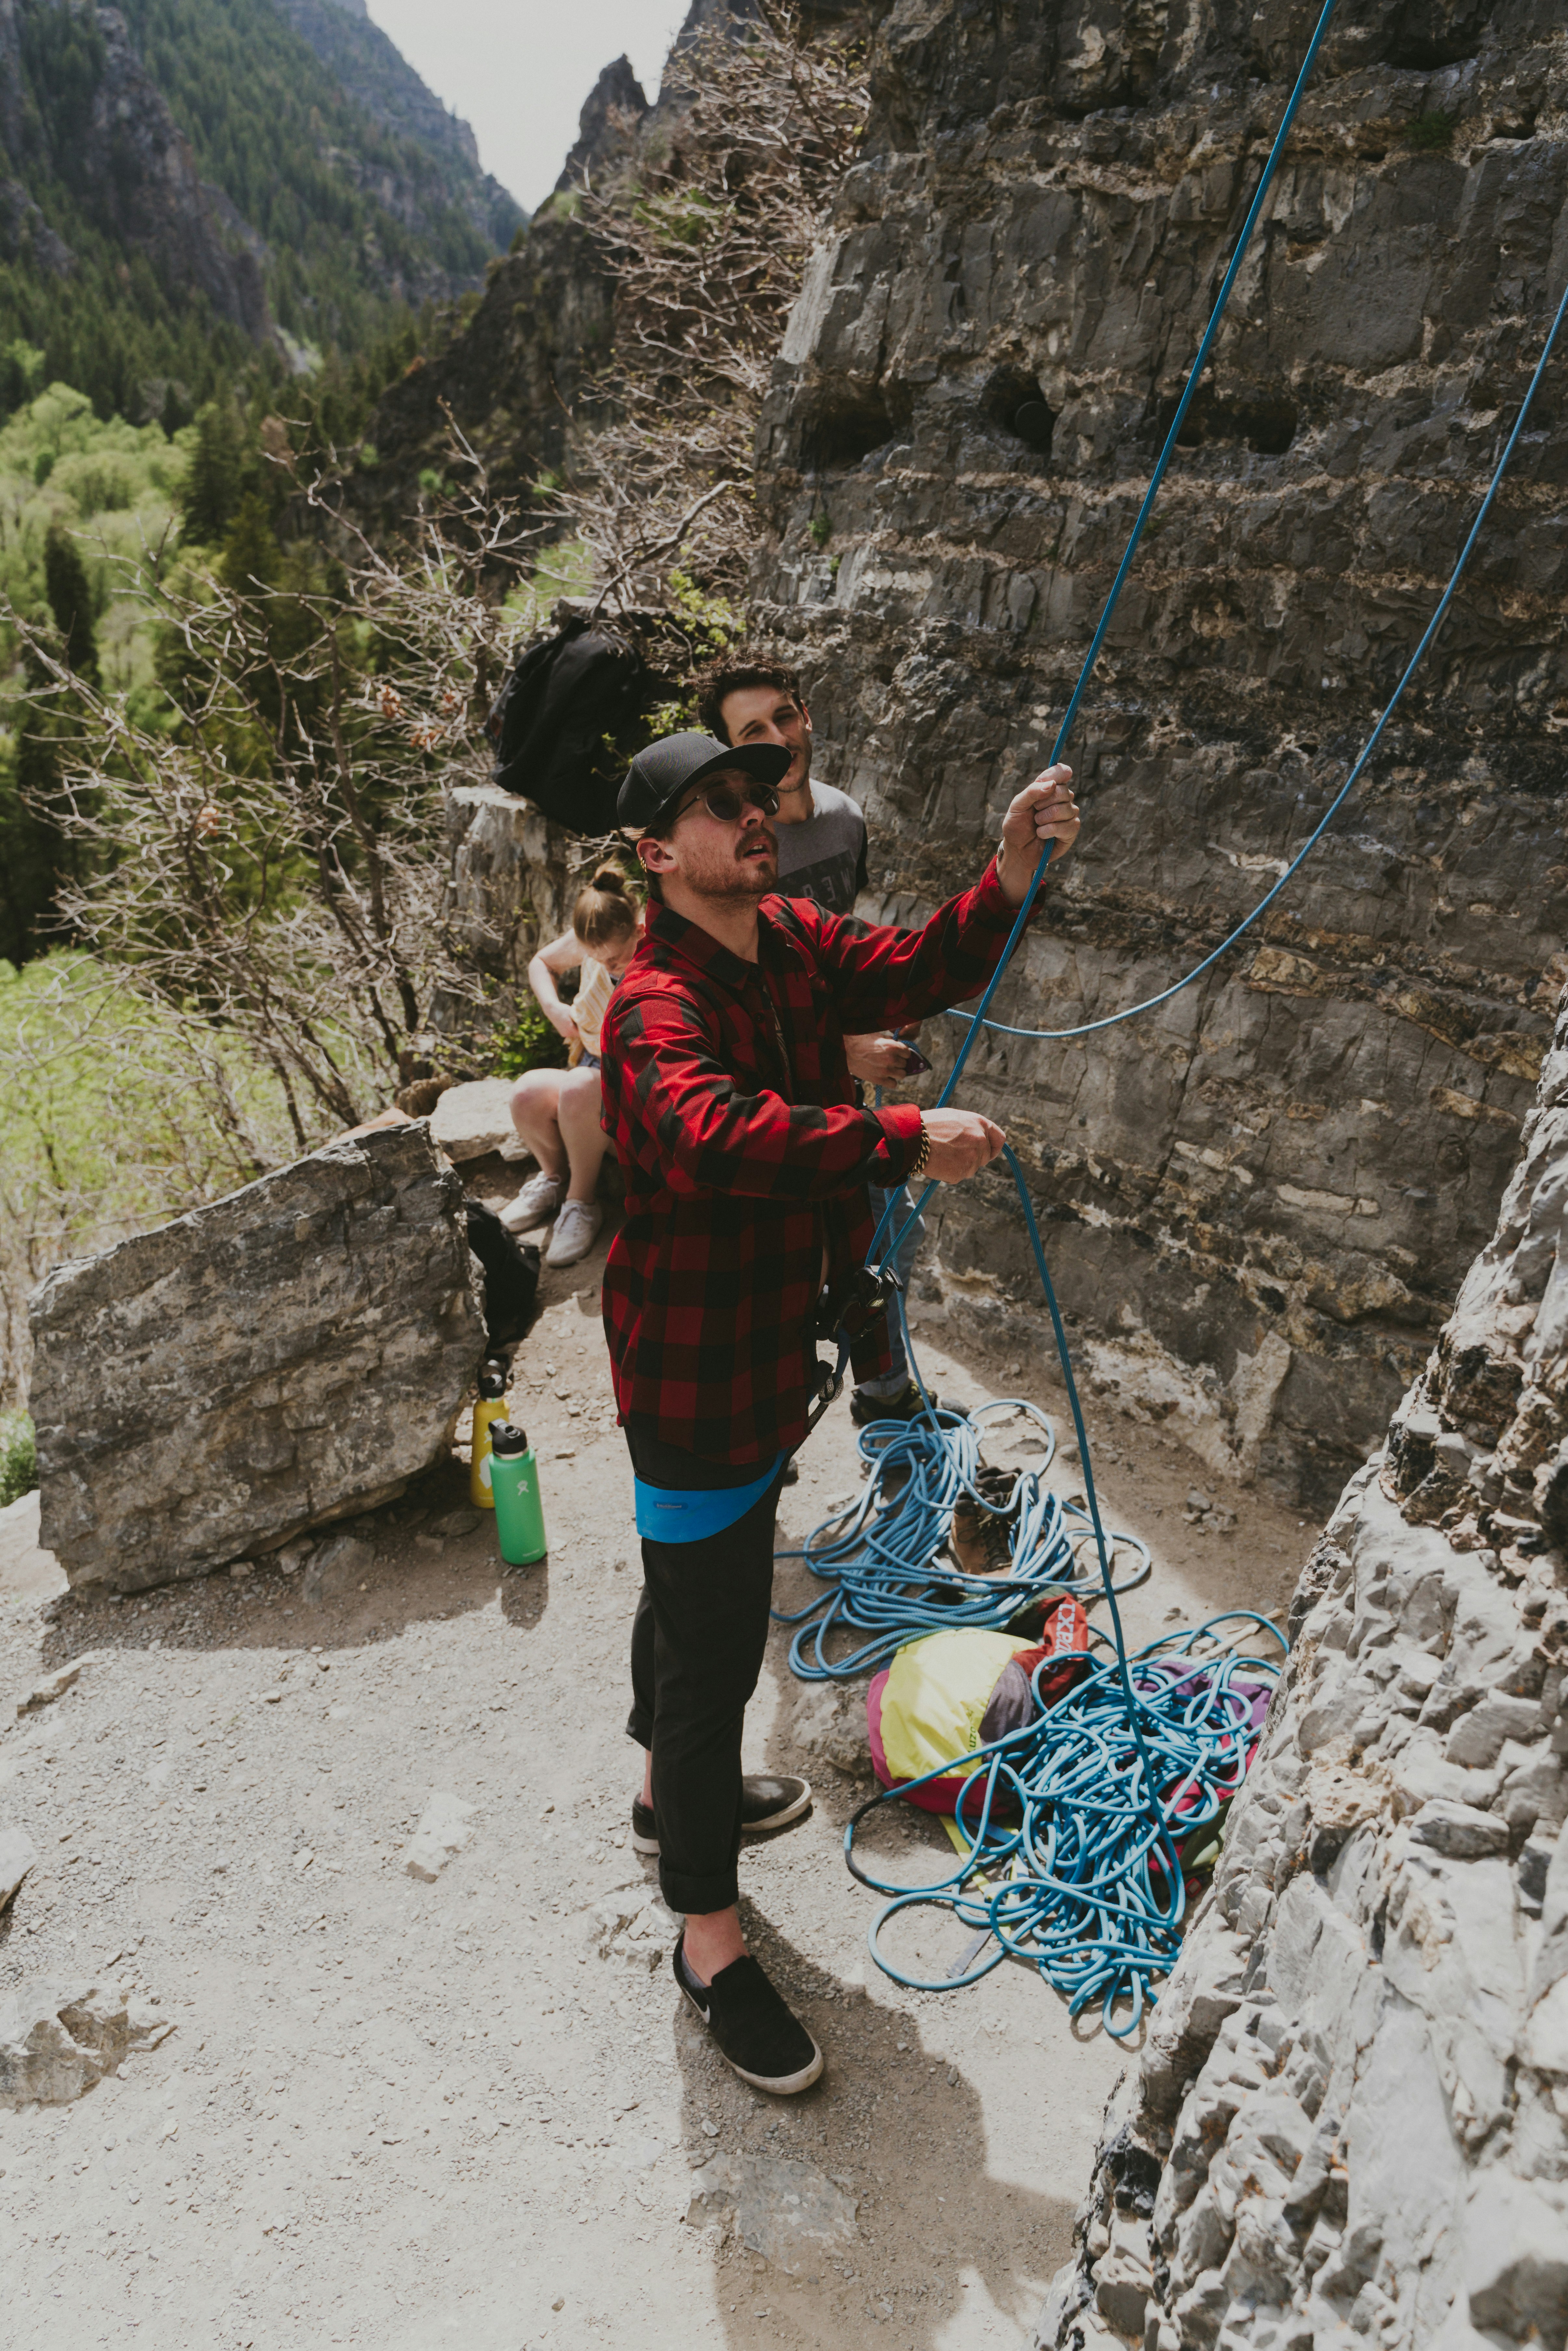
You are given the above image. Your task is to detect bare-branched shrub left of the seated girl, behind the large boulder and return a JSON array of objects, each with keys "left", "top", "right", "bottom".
[{"left": 17, "top": 463, "right": 545, "bottom": 1150}]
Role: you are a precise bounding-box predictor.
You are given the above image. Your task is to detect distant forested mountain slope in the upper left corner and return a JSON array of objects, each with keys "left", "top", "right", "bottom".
[{"left": 0, "top": 0, "right": 522, "bottom": 416}]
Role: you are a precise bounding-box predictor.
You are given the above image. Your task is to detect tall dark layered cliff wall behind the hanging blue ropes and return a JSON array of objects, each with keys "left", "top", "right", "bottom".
[{"left": 752, "top": 0, "right": 1568, "bottom": 1500}]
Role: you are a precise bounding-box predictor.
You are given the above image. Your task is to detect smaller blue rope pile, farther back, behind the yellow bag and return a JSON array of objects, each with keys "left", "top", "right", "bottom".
[{"left": 776, "top": 1382, "right": 1149, "bottom": 1681}]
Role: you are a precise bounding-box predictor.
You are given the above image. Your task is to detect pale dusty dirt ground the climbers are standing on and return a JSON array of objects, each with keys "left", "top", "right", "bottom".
[{"left": 0, "top": 1213, "right": 1302, "bottom": 2351}]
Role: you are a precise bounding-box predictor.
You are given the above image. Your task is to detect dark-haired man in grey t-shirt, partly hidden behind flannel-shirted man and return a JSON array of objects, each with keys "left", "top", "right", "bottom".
[{"left": 698, "top": 654, "right": 924, "bottom": 1425}]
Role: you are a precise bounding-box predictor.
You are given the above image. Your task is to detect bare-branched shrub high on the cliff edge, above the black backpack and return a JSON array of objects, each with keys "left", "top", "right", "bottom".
[{"left": 555, "top": 0, "right": 867, "bottom": 606}]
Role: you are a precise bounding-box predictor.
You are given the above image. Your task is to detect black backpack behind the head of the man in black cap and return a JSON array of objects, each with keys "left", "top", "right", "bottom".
[{"left": 489, "top": 614, "right": 665, "bottom": 835}]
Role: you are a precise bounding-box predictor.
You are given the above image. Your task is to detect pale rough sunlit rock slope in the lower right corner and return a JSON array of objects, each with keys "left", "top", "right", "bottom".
[{"left": 1039, "top": 968, "right": 1568, "bottom": 2351}]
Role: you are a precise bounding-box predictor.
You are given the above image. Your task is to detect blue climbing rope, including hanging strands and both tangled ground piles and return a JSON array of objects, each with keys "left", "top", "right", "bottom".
[{"left": 790, "top": 0, "right": 1568, "bottom": 2036}]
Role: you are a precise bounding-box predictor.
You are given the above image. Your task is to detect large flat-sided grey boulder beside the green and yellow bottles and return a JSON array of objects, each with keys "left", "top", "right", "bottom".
[{"left": 31, "top": 1124, "right": 484, "bottom": 1591}]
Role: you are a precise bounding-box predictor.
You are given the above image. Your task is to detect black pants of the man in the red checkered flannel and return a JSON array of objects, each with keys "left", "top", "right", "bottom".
[{"left": 625, "top": 1418, "right": 783, "bottom": 1916}]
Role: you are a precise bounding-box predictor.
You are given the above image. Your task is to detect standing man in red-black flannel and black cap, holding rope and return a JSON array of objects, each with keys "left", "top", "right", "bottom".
[{"left": 602, "top": 734, "right": 1079, "bottom": 2092}]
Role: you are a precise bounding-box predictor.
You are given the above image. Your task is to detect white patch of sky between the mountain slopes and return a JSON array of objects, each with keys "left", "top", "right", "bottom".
[{"left": 369, "top": 0, "right": 686, "bottom": 212}]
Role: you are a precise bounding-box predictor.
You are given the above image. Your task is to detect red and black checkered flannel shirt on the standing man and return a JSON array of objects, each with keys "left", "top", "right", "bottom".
[{"left": 600, "top": 867, "right": 1043, "bottom": 1462}]
